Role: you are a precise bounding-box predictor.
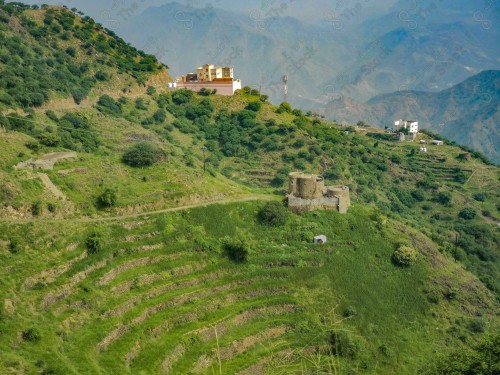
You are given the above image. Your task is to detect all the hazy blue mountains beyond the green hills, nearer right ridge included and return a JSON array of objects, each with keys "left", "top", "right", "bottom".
[{"left": 111, "top": 0, "right": 500, "bottom": 162}]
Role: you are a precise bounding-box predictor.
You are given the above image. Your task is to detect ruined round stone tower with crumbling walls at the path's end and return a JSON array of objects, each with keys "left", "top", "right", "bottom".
[{"left": 287, "top": 172, "right": 351, "bottom": 213}]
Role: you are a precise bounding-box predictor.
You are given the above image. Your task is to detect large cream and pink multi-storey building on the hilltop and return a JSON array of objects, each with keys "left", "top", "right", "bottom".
[{"left": 171, "top": 64, "right": 241, "bottom": 96}]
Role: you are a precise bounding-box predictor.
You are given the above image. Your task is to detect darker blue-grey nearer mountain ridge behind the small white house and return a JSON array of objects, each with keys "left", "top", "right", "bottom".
[{"left": 328, "top": 70, "right": 500, "bottom": 163}]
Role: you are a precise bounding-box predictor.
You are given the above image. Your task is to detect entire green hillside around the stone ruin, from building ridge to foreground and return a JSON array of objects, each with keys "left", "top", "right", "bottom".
[{"left": 0, "top": 6, "right": 500, "bottom": 375}]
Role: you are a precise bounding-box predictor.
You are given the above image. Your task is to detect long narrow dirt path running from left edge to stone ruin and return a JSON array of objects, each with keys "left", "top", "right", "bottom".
[{"left": 0, "top": 194, "right": 276, "bottom": 223}]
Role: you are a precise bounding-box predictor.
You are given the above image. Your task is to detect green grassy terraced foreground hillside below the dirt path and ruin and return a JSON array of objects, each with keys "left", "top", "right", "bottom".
[{"left": 0, "top": 203, "right": 497, "bottom": 374}]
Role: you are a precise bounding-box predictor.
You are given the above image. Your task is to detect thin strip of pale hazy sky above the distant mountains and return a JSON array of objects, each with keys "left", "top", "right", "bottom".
[{"left": 9, "top": 0, "right": 398, "bottom": 29}]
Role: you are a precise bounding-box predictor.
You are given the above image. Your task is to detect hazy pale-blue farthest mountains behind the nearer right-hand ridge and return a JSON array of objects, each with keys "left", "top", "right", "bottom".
[{"left": 116, "top": 0, "right": 500, "bottom": 104}]
